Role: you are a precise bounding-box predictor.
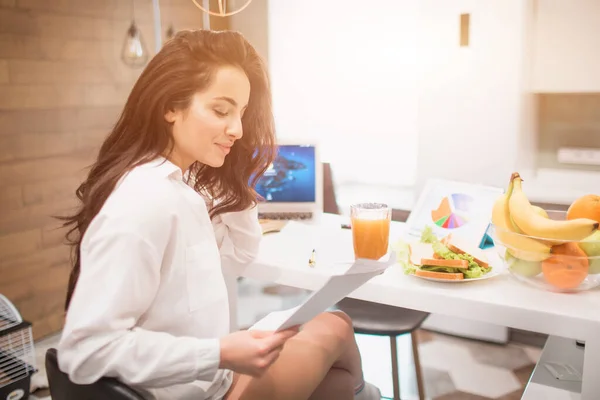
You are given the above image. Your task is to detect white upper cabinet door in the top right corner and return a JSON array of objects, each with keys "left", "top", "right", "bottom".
[{"left": 533, "top": 0, "right": 600, "bottom": 92}]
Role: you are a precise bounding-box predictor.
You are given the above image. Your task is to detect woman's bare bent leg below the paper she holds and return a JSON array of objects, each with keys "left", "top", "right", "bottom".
[{"left": 225, "top": 312, "right": 362, "bottom": 400}]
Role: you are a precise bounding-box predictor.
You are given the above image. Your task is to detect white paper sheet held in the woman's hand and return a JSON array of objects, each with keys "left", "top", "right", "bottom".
[{"left": 250, "top": 252, "right": 396, "bottom": 331}]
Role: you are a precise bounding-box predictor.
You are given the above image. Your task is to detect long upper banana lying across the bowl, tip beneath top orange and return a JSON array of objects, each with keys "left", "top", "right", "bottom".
[{"left": 509, "top": 173, "right": 598, "bottom": 241}]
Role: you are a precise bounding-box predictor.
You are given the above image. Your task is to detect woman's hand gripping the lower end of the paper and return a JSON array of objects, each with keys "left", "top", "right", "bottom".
[{"left": 219, "top": 328, "right": 298, "bottom": 377}]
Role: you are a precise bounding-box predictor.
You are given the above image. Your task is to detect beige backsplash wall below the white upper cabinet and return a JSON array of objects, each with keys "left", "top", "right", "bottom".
[{"left": 537, "top": 93, "right": 600, "bottom": 171}]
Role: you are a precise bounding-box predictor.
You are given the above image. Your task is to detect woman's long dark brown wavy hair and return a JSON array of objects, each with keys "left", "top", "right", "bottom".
[{"left": 61, "top": 30, "right": 276, "bottom": 309}]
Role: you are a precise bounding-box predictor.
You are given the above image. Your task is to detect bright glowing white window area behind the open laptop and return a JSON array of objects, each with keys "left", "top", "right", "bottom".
[{"left": 268, "top": 0, "right": 419, "bottom": 185}]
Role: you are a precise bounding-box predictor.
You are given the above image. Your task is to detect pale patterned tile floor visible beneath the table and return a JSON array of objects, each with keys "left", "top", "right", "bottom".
[{"left": 30, "top": 279, "right": 541, "bottom": 400}]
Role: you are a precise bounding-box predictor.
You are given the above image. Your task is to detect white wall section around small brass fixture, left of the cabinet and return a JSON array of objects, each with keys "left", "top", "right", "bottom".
[{"left": 417, "top": 0, "right": 531, "bottom": 194}]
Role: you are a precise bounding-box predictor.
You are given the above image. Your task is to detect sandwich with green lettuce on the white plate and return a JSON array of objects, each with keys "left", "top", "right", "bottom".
[{"left": 407, "top": 227, "right": 492, "bottom": 281}]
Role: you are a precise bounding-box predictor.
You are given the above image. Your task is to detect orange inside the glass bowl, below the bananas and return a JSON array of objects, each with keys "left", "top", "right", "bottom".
[{"left": 542, "top": 242, "right": 590, "bottom": 289}]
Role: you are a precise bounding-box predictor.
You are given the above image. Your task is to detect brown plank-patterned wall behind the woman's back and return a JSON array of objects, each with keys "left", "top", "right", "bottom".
[{"left": 0, "top": 0, "right": 211, "bottom": 338}]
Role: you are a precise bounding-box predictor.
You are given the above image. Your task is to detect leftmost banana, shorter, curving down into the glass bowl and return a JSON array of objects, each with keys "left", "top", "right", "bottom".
[{"left": 492, "top": 175, "right": 551, "bottom": 261}]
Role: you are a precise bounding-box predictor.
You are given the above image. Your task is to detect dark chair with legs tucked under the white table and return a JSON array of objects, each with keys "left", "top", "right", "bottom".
[{"left": 323, "top": 163, "right": 429, "bottom": 400}]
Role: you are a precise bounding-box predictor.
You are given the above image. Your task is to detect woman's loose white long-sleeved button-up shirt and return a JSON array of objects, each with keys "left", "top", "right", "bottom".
[{"left": 58, "top": 158, "right": 261, "bottom": 400}]
